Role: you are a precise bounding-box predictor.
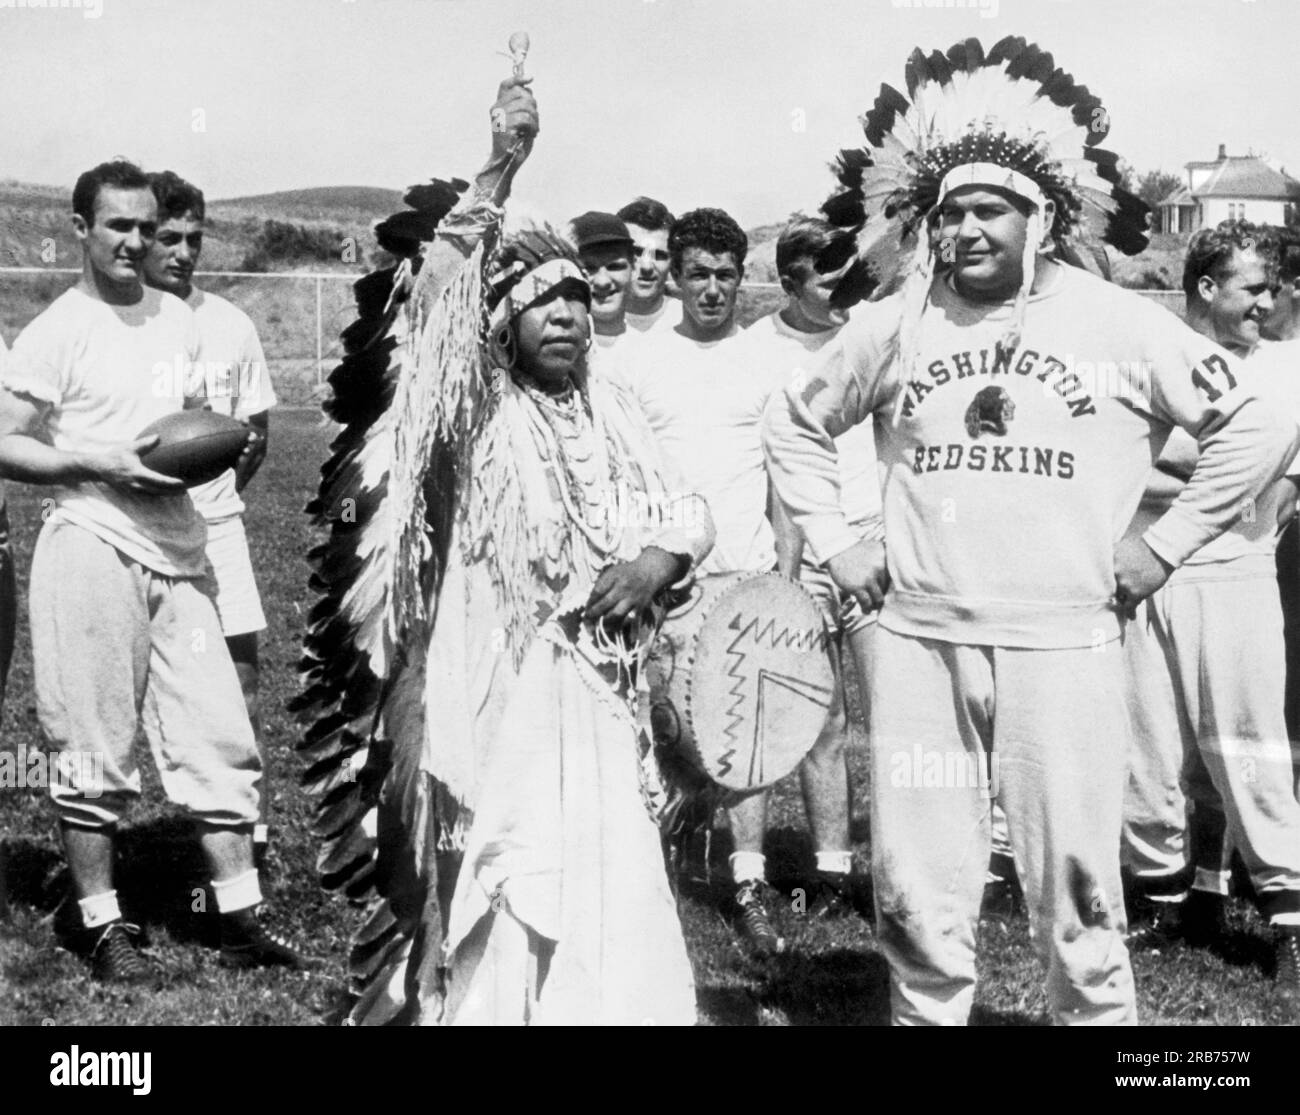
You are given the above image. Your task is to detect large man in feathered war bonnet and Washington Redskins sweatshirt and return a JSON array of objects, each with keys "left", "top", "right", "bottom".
[{"left": 766, "top": 38, "right": 1300, "bottom": 1024}]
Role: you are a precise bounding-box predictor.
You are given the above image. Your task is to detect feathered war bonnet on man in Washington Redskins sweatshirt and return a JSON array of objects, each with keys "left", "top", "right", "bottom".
[{"left": 822, "top": 36, "right": 1148, "bottom": 405}]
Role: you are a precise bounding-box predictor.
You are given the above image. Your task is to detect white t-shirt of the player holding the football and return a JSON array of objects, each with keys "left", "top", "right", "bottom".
[{"left": 4, "top": 287, "right": 207, "bottom": 577}]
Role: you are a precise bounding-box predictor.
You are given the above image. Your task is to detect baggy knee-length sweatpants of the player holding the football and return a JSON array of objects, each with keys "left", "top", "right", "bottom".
[{"left": 29, "top": 521, "right": 261, "bottom": 829}]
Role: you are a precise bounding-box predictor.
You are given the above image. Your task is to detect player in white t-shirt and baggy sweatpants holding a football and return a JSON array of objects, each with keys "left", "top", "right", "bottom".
[{"left": 0, "top": 160, "right": 306, "bottom": 982}]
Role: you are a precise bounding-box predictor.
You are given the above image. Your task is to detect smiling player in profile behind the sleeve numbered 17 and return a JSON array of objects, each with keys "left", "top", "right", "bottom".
[{"left": 1125, "top": 222, "right": 1300, "bottom": 998}]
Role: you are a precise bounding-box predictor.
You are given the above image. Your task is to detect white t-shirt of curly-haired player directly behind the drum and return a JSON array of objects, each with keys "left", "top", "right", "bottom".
[{"left": 628, "top": 317, "right": 787, "bottom": 573}]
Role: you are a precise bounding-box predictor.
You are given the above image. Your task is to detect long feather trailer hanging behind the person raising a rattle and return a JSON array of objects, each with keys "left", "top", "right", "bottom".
[{"left": 290, "top": 179, "right": 478, "bottom": 1021}]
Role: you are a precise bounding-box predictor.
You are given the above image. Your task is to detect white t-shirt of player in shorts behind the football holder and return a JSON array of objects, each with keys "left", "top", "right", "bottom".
[{"left": 186, "top": 287, "right": 276, "bottom": 522}]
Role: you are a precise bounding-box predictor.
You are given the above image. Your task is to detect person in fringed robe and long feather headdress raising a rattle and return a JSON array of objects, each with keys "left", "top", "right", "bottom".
[{"left": 298, "top": 65, "right": 714, "bottom": 1025}]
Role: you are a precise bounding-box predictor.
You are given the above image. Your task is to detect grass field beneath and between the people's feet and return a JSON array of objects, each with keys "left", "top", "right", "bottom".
[{"left": 0, "top": 411, "right": 1287, "bottom": 1025}]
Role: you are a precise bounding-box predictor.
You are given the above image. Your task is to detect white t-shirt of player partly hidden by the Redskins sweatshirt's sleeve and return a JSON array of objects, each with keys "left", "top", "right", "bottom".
[{"left": 737, "top": 309, "right": 884, "bottom": 541}]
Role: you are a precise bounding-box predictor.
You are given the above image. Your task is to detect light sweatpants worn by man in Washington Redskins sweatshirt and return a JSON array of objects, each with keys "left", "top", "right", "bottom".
[{"left": 870, "top": 629, "right": 1136, "bottom": 1025}]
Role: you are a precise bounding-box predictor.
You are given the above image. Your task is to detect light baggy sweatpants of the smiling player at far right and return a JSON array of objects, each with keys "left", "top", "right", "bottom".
[{"left": 1125, "top": 567, "right": 1300, "bottom": 924}]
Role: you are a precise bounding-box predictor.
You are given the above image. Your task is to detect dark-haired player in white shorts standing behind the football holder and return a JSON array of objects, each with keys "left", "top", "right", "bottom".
[{"left": 144, "top": 170, "right": 276, "bottom": 862}]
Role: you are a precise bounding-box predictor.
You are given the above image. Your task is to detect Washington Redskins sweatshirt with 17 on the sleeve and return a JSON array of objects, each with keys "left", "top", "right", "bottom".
[{"left": 764, "top": 268, "right": 1300, "bottom": 648}]
